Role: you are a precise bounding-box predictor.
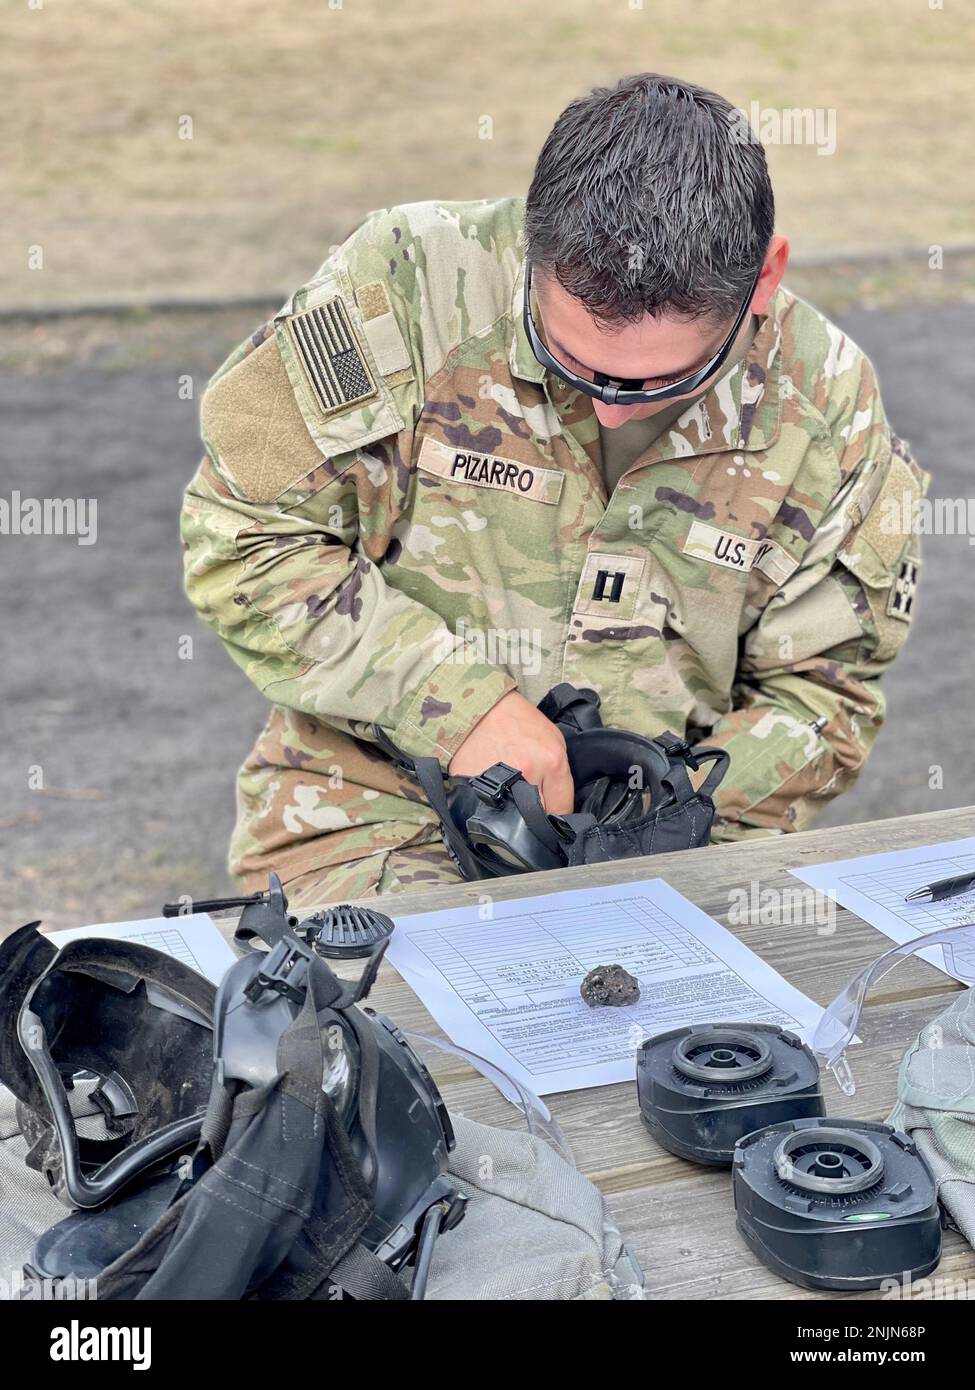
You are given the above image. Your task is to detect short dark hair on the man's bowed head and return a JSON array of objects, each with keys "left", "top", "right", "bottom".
[{"left": 524, "top": 72, "right": 775, "bottom": 325}]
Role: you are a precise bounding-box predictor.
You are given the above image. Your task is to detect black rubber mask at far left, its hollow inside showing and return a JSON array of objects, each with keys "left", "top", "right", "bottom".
[{"left": 0, "top": 923, "right": 216, "bottom": 1208}]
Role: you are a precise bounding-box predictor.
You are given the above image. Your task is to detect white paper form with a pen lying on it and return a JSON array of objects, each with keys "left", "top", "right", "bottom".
[{"left": 790, "top": 835, "right": 975, "bottom": 973}]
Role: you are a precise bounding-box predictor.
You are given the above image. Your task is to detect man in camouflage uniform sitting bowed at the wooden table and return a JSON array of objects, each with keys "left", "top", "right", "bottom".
[{"left": 182, "top": 74, "right": 926, "bottom": 905}]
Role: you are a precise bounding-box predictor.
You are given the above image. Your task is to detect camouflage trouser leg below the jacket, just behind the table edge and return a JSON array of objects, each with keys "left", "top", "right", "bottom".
[{"left": 236, "top": 844, "right": 463, "bottom": 910}]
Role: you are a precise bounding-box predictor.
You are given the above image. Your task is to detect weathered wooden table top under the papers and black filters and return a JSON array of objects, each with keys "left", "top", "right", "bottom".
[{"left": 218, "top": 806, "right": 975, "bottom": 1298}]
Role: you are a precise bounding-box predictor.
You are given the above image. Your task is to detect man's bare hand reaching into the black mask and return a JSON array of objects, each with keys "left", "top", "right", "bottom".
[{"left": 449, "top": 691, "right": 576, "bottom": 816}]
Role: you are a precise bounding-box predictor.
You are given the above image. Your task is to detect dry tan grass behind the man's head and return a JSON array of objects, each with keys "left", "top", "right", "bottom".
[{"left": 0, "top": 0, "right": 975, "bottom": 304}]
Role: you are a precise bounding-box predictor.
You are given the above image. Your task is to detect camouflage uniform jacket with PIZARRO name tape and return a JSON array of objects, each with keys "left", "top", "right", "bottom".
[{"left": 182, "top": 199, "right": 926, "bottom": 900}]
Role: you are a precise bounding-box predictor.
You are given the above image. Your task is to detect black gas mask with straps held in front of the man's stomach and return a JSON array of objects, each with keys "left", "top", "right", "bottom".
[{"left": 376, "top": 684, "right": 729, "bottom": 880}]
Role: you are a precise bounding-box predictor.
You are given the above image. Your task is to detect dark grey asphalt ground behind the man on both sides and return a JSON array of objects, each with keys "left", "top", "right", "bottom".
[{"left": 0, "top": 304, "right": 975, "bottom": 933}]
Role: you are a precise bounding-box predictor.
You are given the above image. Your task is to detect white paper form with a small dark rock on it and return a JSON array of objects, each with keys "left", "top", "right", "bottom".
[{"left": 385, "top": 878, "right": 822, "bottom": 1095}]
